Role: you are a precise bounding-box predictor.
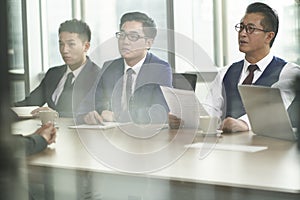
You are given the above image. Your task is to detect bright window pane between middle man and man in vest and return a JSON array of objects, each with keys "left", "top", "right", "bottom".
[{"left": 174, "top": 0, "right": 214, "bottom": 72}]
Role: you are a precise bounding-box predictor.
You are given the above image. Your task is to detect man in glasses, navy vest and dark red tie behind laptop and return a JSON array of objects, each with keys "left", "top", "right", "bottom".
[{"left": 169, "top": 3, "right": 300, "bottom": 132}]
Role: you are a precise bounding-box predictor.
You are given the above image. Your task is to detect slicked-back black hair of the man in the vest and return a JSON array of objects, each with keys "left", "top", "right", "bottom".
[{"left": 246, "top": 2, "right": 279, "bottom": 47}]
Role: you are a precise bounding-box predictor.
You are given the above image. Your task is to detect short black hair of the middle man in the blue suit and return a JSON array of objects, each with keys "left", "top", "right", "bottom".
[{"left": 120, "top": 12, "right": 157, "bottom": 39}]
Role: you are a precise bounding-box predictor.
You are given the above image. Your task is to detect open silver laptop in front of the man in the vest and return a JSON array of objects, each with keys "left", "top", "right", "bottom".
[{"left": 238, "top": 85, "right": 297, "bottom": 141}]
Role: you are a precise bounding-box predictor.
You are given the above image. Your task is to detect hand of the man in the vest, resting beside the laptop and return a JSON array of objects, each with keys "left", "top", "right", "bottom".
[{"left": 222, "top": 117, "right": 249, "bottom": 133}]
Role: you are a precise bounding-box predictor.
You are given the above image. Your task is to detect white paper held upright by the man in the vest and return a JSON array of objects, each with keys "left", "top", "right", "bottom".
[{"left": 161, "top": 86, "right": 208, "bottom": 127}]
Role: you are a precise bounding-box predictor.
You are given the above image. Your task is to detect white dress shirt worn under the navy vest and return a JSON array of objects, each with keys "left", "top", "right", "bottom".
[{"left": 203, "top": 53, "right": 300, "bottom": 129}]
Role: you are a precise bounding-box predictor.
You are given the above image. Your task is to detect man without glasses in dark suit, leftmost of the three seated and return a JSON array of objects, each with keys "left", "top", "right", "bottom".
[{"left": 15, "top": 19, "right": 100, "bottom": 117}]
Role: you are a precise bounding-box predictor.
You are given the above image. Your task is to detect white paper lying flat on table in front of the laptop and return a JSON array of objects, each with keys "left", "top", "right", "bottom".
[{"left": 185, "top": 142, "right": 268, "bottom": 153}]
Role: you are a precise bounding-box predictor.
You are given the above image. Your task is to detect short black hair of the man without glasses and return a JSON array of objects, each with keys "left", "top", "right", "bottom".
[{"left": 58, "top": 19, "right": 91, "bottom": 42}]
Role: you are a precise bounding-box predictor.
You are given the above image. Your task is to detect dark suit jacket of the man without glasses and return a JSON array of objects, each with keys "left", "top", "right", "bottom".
[{"left": 15, "top": 58, "right": 100, "bottom": 117}]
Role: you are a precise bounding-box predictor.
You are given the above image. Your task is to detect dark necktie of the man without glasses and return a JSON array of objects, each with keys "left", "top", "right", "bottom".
[{"left": 56, "top": 72, "right": 74, "bottom": 117}]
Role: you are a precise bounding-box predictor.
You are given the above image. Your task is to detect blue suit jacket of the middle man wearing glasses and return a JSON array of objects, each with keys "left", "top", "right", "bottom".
[{"left": 78, "top": 53, "right": 172, "bottom": 123}]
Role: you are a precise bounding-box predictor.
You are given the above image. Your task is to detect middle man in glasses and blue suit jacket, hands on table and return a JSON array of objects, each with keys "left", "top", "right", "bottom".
[{"left": 78, "top": 12, "right": 172, "bottom": 124}]
